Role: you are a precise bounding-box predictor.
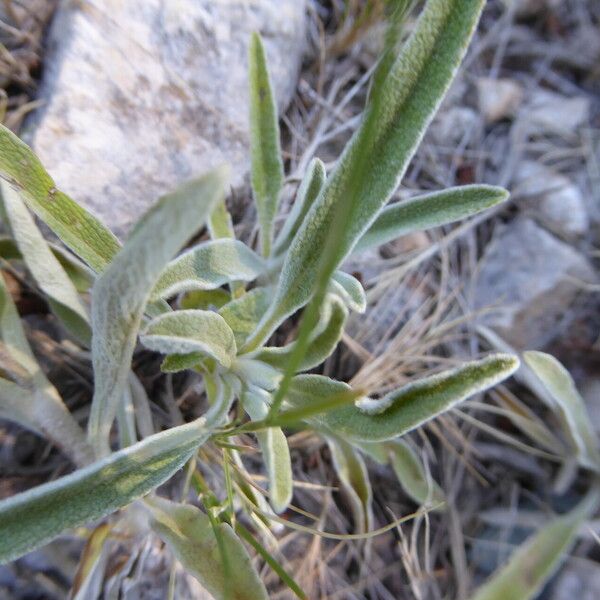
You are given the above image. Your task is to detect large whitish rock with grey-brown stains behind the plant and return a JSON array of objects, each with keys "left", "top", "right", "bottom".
[{"left": 30, "top": 0, "right": 305, "bottom": 236}]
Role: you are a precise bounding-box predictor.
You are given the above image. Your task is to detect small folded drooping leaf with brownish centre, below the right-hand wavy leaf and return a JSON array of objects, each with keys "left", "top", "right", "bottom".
[{"left": 327, "top": 437, "right": 373, "bottom": 533}]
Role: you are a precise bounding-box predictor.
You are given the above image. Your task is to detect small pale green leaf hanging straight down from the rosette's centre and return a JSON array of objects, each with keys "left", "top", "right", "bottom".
[{"left": 243, "top": 389, "right": 293, "bottom": 513}]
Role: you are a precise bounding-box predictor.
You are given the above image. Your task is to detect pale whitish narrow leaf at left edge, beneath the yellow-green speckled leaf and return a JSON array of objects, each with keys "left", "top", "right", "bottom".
[{"left": 0, "top": 183, "right": 91, "bottom": 343}]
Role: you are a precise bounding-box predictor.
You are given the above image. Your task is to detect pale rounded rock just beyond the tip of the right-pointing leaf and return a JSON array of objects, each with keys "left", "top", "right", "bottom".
[{"left": 513, "top": 161, "right": 590, "bottom": 237}]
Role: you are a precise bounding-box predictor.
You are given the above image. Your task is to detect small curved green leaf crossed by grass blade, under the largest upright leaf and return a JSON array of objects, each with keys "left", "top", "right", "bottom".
[{"left": 256, "top": 296, "right": 348, "bottom": 371}]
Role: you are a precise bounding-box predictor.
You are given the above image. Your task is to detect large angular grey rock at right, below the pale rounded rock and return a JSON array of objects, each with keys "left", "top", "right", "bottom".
[{"left": 474, "top": 217, "right": 595, "bottom": 349}]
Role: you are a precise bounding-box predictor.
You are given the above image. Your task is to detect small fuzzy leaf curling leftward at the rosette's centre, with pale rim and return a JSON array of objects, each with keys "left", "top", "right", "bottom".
[{"left": 140, "top": 310, "right": 237, "bottom": 367}]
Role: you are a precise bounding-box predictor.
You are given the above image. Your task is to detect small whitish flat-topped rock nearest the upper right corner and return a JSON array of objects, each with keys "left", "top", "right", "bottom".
[{"left": 519, "top": 89, "right": 591, "bottom": 134}]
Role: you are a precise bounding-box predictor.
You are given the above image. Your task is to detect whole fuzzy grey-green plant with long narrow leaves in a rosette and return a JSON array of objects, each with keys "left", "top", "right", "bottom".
[{"left": 0, "top": 0, "right": 518, "bottom": 599}]
